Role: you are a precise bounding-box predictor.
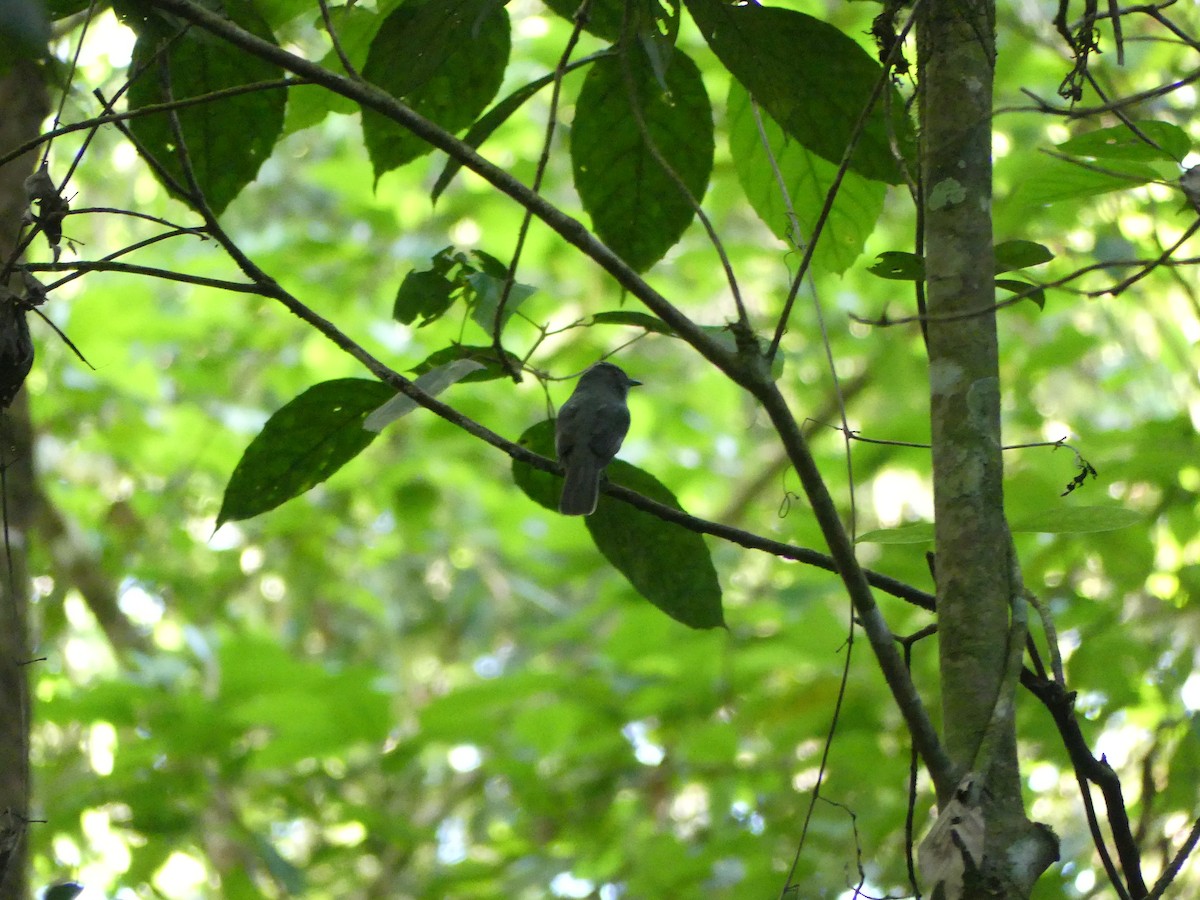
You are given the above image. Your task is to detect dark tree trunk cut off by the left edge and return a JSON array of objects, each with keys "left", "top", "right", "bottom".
[{"left": 0, "top": 62, "right": 47, "bottom": 900}]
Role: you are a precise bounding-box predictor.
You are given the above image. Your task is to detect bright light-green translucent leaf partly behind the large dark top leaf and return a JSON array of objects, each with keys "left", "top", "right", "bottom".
[{"left": 728, "top": 82, "right": 887, "bottom": 275}]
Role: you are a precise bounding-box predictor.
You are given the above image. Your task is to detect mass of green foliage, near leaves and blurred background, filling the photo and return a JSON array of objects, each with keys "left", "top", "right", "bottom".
[{"left": 7, "top": 0, "right": 1200, "bottom": 899}]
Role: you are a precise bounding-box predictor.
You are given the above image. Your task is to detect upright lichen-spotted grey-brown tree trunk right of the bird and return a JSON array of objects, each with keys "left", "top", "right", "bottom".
[{"left": 918, "top": 0, "right": 1056, "bottom": 898}]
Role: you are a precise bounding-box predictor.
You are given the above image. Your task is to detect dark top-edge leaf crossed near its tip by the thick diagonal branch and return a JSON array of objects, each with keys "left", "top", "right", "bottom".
[{"left": 362, "top": 0, "right": 510, "bottom": 179}]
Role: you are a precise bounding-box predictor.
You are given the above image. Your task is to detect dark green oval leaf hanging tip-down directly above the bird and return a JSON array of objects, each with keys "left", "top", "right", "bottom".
[{"left": 571, "top": 48, "right": 713, "bottom": 271}]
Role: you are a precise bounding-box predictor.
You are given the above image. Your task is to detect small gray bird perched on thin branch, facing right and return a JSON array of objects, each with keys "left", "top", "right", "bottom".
[{"left": 554, "top": 362, "right": 641, "bottom": 516}]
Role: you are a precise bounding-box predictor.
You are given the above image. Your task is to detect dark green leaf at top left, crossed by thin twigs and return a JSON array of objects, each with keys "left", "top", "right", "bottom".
[{"left": 127, "top": 2, "right": 287, "bottom": 215}]
